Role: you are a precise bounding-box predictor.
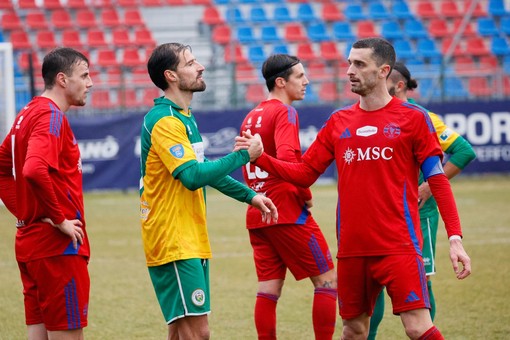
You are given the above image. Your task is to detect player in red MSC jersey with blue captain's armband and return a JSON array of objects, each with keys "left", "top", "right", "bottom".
[{"left": 236, "top": 38, "right": 471, "bottom": 339}]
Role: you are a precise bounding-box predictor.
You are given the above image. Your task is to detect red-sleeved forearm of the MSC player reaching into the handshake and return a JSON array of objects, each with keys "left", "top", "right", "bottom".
[{"left": 255, "top": 153, "right": 320, "bottom": 188}]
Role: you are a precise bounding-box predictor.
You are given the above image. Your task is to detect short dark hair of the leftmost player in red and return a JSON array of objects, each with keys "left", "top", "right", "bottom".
[{"left": 42, "top": 47, "right": 89, "bottom": 89}]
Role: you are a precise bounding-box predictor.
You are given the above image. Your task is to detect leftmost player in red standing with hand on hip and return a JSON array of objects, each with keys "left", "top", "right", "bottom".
[{"left": 0, "top": 48, "right": 92, "bottom": 339}]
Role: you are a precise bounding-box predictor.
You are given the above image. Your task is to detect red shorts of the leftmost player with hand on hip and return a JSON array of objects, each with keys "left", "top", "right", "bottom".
[{"left": 18, "top": 255, "right": 90, "bottom": 331}]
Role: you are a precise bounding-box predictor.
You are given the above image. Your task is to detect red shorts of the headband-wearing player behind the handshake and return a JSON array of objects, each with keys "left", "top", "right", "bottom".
[{"left": 249, "top": 218, "right": 334, "bottom": 281}]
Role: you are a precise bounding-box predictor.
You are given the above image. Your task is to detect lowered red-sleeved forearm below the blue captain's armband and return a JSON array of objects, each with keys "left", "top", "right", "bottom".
[{"left": 427, "top": 174, "right": 462, "bottom": 237}]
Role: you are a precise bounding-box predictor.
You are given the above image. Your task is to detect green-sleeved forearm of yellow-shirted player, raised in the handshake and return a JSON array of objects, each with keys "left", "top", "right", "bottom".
[{"left": 177, "top": 150, "right": 250, "bottom": 191}]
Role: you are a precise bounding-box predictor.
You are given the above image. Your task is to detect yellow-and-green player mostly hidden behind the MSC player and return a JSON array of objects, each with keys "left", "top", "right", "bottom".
[{"left": 368, "top": 62, "right": 476, "bottom": 340}]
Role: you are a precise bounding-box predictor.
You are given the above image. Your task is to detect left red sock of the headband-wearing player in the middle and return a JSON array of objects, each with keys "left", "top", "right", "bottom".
[{"left": 255, "top": 293, "right": 278, "bottom": 340}]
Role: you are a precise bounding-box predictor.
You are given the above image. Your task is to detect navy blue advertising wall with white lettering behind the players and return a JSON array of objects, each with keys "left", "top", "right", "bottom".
[{"left": 69, "top": 101, "right": 510, "bottom": 190}]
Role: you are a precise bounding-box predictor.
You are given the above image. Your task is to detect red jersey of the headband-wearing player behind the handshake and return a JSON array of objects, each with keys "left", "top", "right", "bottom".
[{"left": 241, "top": 99, "right": 312, "bottom": 229}]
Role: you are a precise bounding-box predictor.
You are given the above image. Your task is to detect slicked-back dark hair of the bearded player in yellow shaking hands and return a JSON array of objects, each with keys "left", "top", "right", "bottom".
[{"left": 147, "top": 43, "right": 191, "bottom": 91}]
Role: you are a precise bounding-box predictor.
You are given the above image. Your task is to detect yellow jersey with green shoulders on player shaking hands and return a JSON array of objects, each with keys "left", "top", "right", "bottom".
[{"left": 140, "top": 97, "right": 211, "bottom": 267}]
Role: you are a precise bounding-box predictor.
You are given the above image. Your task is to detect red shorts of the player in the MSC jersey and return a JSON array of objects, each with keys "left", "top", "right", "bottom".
[{"left": 337, "top": 255, "right": 430, "bottom": 319}]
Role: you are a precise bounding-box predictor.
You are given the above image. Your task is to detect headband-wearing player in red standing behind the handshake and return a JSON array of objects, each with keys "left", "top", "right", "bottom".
[{"left": 241, "top": 54, "right": 337, "bottom": 340}]
